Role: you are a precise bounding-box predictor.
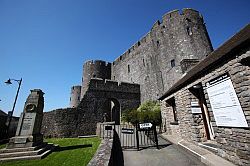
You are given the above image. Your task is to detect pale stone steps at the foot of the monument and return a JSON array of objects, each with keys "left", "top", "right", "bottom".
[{"left": 0, "top": 144, "right": 56, "bottom": 163}]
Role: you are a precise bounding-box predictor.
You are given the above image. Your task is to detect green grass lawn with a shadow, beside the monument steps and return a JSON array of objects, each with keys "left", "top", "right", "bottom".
[{"left": 1, "top": 137, "right": 101, "bottom": 166}]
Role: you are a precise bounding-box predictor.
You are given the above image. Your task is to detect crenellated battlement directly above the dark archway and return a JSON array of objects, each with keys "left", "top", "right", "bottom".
[{"left": 88, "top": 78, "right": 140, "bottom": 93}]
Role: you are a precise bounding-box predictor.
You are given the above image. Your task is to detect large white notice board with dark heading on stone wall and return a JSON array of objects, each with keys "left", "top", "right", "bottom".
[{"left": 206, "top": 74, "right": 248, "bottom": 127}]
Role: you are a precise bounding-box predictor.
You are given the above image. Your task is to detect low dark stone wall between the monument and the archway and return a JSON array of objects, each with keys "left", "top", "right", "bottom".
[{"left": 41, "top": 108, "right": 100, "bottom": 137}]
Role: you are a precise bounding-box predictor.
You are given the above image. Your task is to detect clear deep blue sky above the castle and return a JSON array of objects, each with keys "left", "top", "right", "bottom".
[{"left": 0, "top": 0, "right": 250, "bottom": 116}]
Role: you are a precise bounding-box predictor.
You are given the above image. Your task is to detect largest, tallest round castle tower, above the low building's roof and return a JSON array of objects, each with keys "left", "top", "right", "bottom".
[{"left": 163, "top": 8, "right": 213, "bottom": 62}]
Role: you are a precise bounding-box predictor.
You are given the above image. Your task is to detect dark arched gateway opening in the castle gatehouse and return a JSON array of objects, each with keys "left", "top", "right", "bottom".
[{"left": 103, "top": 98, "right": 121, "bottom": 124}]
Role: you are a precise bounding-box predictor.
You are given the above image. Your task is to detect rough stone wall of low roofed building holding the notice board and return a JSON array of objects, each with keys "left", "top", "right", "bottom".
[{"left": 161, "top": 47, "right": 250, "bottom": 165}]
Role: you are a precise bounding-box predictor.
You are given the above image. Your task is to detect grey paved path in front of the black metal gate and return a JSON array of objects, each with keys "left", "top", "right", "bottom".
[{"left": 123, "top": 137, "right": 204, "bottom": 166}]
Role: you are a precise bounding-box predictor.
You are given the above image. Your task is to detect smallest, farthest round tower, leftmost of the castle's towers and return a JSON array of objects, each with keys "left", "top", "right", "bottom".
[{"left": 70, "top": 85, "right": 81, "bottom": 108}]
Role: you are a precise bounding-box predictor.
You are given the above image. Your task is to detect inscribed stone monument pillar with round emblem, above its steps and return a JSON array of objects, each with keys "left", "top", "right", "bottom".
[{"left": 7, "top": 89, "right": 44, "bottom": 148}]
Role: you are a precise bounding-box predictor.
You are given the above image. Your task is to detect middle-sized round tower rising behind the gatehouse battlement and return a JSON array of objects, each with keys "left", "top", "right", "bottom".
[{"left": 81, "top": 60, "right": 111, "bottom": 98}]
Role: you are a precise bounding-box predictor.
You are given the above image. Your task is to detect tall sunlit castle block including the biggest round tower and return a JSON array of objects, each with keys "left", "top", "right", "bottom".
[{"left": 111, "top": 9, "right": 212, "bottom": 101}]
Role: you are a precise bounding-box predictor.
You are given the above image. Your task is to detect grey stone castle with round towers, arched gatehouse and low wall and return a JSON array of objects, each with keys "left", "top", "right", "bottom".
[{"left": 42, "top": 9, "right": 213, "bottom": 137}]
